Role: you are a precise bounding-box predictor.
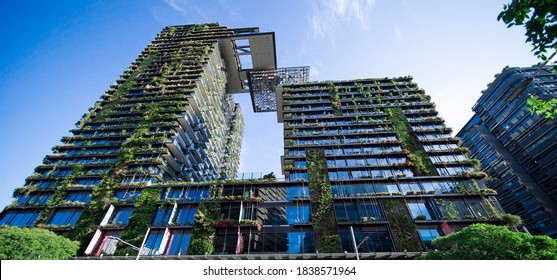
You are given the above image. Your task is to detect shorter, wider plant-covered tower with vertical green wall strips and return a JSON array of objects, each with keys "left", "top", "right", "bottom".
[{"left": 278, "top": 77, "right": 504, "bottom": 252}]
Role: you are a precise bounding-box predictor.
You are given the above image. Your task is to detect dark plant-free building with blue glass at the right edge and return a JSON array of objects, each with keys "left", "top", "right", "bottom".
[{"left": 458, "top": 66, "right": 557, "bottom": 238}]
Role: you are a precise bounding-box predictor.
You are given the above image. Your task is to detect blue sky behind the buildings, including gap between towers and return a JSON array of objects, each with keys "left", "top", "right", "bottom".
[{"left": 0, "top": 0, "right": 538, "bottom": 207}]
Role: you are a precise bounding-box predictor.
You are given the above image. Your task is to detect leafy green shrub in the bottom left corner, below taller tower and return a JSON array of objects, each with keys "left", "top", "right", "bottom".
[{"left": 0, "top": 226, "right": 79, "bottom": 260}]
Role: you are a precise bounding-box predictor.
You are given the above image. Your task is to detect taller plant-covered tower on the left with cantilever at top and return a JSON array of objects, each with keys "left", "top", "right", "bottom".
[{"left": 0, "top": 24, "right": 276, "bottom": 252}]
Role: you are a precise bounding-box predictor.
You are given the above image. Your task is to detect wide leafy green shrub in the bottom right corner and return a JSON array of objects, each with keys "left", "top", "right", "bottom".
[{"left": 419, "top": 224, "right": 557, "bottom": 260}]
